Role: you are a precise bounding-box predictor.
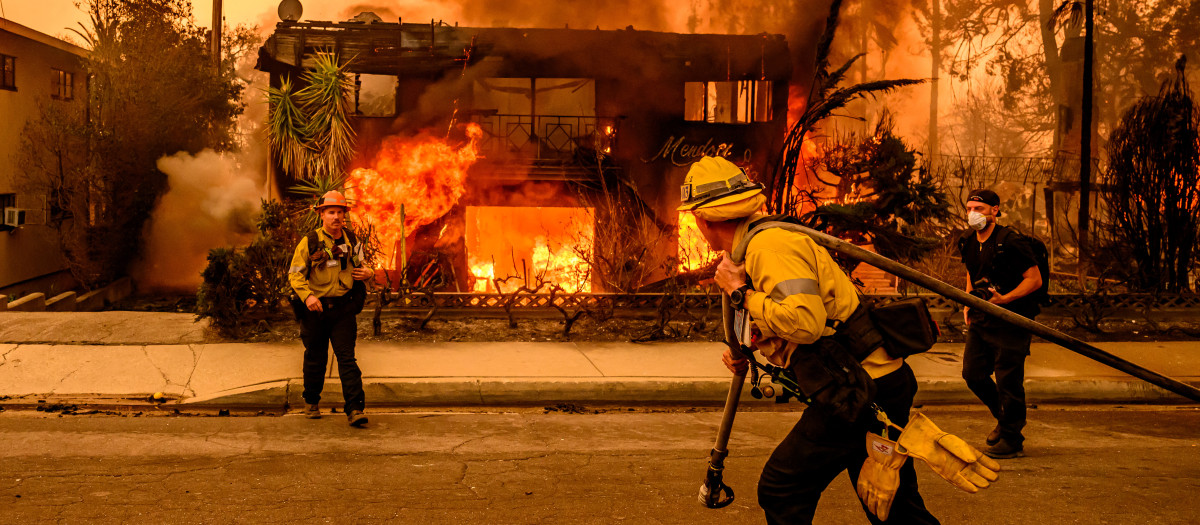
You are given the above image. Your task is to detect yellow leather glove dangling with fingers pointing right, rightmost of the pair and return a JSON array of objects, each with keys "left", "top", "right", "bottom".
[{"left": 896, "top": 414, "right": 1000, "bottom": 494}]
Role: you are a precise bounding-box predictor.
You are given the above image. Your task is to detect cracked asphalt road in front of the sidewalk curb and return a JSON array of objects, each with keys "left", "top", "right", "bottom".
[{"left": 0, "top": 406, "right": 1200, "bottom": 524}]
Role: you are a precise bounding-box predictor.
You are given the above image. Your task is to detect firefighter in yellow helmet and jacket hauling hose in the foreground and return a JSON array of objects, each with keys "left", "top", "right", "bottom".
[{"left": 679, "top": 157, "right": 937, "bottom": 524}]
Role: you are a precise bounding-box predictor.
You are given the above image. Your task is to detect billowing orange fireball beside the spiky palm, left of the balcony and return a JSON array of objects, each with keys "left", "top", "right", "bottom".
[{"left": 347, "top": 123, "right": 484, "bottom": 264}]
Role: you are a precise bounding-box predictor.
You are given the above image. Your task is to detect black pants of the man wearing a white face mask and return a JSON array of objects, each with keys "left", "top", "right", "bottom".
[{"left": 962, "top": 322, "right": 1032, "bottom": 446}]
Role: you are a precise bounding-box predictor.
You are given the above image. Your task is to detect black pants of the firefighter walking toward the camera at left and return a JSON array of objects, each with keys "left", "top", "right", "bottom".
[{"left": 300, "top": 298, "right": 366, "bottom": 412}]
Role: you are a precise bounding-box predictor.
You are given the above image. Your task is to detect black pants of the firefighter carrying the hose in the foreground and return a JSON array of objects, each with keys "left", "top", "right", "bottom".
[{"left": 758, "top": 363, "right": 938, "bottom": 524}]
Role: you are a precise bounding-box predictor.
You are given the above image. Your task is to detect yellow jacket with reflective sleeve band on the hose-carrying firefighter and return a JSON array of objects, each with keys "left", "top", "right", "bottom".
[{"left": 733, "top": 215, "right": 904, "bottom": 378}]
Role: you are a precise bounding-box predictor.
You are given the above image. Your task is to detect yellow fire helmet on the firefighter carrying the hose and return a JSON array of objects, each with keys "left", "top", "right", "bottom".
[{"left": 677, "top": 157, "right": 764, "bottom": 215}]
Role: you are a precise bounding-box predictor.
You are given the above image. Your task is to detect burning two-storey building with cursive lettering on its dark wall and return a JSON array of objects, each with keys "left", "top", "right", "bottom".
[{"left": 257, "top": 13, "right": 792, "bottom": 291}]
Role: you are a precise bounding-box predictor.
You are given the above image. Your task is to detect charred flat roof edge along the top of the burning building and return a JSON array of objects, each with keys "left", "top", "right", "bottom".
[{"left": 259, "top": 22, "right": 792, "bottom": 80}]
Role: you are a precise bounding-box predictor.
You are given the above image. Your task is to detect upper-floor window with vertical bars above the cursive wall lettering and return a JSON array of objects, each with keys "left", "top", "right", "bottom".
[{"left": 684, "top": 80, "right": 772, "bottom": 123}]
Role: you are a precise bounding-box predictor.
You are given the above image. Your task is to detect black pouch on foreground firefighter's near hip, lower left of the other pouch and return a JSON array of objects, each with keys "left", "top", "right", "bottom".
[{"left": 791, "top": 337, "right": 875, "bottom": 423}]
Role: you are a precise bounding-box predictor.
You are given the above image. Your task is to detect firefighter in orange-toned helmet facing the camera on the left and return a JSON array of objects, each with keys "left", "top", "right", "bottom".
[{"left": 288, "top": 191, "right": 374, "bottom": 428}]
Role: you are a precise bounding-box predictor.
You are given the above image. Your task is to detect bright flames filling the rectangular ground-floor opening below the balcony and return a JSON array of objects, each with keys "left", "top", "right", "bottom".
[{"left": 466, "top": 206, "right": 594, "bottom": 294}]
